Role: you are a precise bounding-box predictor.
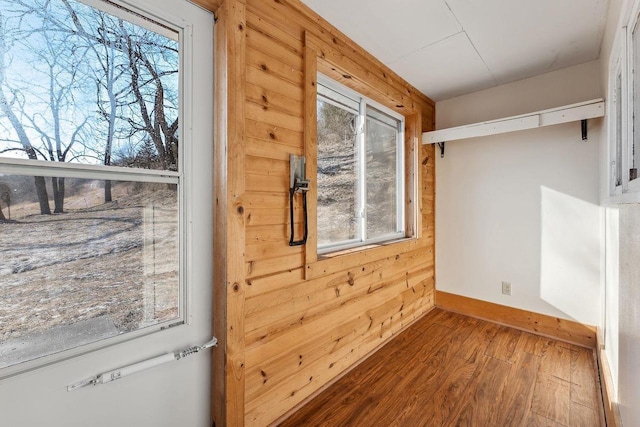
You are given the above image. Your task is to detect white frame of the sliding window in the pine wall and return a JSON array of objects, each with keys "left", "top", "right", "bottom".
[{"left": 317, "top": 73, "right": 407, "bottom": 254}]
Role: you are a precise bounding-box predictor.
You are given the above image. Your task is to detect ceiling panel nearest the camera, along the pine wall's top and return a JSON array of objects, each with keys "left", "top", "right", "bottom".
[{"left": 304, "top": 0, "right": 460, "bottom": 63}]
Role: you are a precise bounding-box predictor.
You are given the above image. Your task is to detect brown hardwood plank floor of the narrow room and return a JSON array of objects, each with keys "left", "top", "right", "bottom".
[{"left": 280, "top": 309, "right": 605, "bottom": 427}]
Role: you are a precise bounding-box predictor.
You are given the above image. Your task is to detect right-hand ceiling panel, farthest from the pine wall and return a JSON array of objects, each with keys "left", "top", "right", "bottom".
[{"left": 447, "top": 0, "right": 607, "bottom": 84}]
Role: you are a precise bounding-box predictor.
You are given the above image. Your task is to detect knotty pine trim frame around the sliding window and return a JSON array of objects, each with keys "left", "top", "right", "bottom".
[{"left": 302, "top": 31, "right": 434, "bottom": 280}]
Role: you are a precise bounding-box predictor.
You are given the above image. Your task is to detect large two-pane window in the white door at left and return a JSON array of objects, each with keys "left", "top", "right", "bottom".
[{"left": 0, "top": 0, "right": 186, "bottom": 376}]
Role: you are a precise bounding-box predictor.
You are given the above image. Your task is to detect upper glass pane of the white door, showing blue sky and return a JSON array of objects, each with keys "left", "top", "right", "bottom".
[{"left": 0, "top": 0, "right": 179, "bottom": 170}]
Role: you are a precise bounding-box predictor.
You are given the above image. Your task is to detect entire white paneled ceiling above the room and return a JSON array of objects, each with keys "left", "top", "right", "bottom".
[{"left": 302, "top": 0, "right": 608, "bottom": 101}]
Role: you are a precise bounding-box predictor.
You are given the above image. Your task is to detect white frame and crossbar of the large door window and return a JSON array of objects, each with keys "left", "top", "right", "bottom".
[{"left": 0, "top": 0, "right": 198, "bottom": 380}]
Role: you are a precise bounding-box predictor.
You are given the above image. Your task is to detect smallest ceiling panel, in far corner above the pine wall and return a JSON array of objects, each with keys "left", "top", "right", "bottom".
[{"left": 391, "top": 32, "right": 496, "bottom": 100}]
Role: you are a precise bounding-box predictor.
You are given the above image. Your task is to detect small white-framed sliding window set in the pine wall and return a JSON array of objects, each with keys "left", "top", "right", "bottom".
[{"left": 317, "top": 76, "right": 405, "bottom": 253}]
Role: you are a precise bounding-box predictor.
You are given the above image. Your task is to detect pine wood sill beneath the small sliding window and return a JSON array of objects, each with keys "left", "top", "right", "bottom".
[{"left": 305, "top": 237, "right": 430, "bottom": 280}]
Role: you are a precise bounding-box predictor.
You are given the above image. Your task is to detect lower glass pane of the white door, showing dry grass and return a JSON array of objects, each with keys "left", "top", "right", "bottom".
[{"left": 0, "top": 175, "right": 179, "bottom": 367}]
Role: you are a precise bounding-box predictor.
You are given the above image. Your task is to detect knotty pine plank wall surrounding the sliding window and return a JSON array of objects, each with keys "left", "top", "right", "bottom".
[{"left": 212, "top": 0, "right": 435, "bottom": 426}]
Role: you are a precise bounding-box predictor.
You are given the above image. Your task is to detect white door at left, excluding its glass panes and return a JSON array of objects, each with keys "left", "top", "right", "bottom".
[{"left": 0, "top": 0, "right": 213, "bottom": 427}]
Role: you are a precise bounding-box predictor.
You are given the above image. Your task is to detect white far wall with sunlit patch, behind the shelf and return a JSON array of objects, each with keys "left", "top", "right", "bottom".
[{"left": 436, "top": 61, "right": 603, "bottom": 325}]
